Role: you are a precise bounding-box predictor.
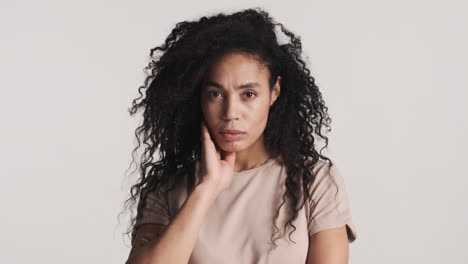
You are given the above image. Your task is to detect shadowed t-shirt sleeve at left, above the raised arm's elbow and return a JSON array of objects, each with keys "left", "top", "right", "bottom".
[{"left": 134, "top": 188, "right": 170, "bottom": 229}]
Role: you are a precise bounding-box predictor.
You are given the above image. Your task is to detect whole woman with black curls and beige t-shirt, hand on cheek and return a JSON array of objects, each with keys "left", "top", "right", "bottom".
[{"left": 127, "top": 8, "right": 356, "bottom": 264}]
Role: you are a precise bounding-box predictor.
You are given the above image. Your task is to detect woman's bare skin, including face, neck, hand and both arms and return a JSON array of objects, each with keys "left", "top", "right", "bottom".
[{"left": 126, "top": 53, "right": 349, "bottom": 264}]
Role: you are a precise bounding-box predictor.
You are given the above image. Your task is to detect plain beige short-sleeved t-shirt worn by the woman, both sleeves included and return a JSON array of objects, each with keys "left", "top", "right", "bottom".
[{"left": 133, "top": 158, "right": 356, "bottom": 264}]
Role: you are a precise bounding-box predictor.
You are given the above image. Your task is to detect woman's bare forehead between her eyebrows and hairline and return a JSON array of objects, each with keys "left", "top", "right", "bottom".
[{"left": 204, "top": 53, "right": 269, "bottom": 85}]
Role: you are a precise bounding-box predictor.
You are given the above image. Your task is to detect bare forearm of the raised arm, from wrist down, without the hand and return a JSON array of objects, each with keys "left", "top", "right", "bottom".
[{"left": 145, "top": 184, "right": 217, "bottom": 264}]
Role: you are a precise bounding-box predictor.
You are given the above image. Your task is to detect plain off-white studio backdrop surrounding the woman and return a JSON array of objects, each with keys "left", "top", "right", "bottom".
[{"left": 0, "top": 0, "right": 468, "bottom": 264}]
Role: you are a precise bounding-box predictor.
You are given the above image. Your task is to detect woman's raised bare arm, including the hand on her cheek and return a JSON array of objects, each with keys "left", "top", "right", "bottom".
[{"left": 127, "top": 120, "right": 236, "bottom": 264}]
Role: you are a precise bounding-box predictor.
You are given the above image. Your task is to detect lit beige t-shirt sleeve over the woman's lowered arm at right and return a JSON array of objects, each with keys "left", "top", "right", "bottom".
[{"left": 308, "top": 162, "right": 356, "bottom": 243}]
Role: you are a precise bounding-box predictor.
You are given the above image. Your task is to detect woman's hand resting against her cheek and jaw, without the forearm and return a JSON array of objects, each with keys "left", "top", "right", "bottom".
[{"left": 200, "top": 119, "right": 236, "bottom": 196}]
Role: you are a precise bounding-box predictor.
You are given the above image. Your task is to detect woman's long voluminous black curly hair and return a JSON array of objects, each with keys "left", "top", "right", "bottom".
[{"left": 121, "top": 7, "right": 333, "bottom": 248}]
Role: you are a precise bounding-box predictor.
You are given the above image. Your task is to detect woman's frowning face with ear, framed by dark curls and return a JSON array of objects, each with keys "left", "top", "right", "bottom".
[{"left": 200, "top": 53, "right": 280, "bottom": 152}]
